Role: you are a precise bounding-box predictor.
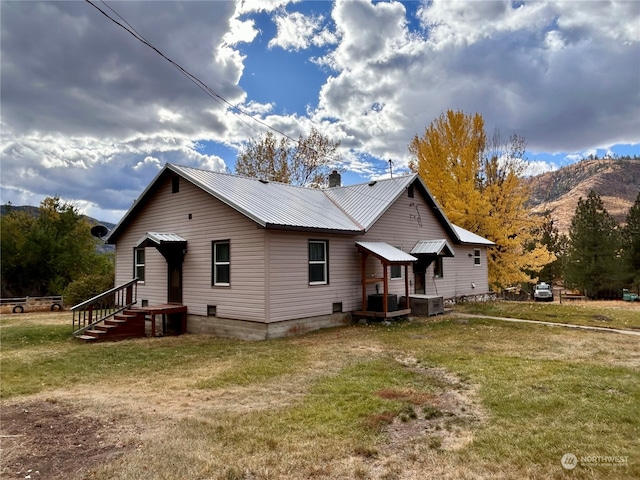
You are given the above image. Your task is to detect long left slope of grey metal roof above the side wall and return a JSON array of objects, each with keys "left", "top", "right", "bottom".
[{"left": 168, "top": 165, "right": 361, "bottom": 232}]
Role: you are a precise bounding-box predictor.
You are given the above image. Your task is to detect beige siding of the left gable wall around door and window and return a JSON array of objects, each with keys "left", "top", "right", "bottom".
[{"left": 116, "top": 176, "right": 265, "bottom": 321}]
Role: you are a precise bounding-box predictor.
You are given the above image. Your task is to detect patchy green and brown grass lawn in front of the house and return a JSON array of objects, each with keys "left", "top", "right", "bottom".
[{"left": 0, "top": 304, "right": 640, "bottom": 480}]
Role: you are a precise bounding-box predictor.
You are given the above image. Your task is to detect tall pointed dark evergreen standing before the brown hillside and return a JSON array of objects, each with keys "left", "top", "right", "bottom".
[{"left": 565, "top": 190, "right": 621, "bottom": 298}]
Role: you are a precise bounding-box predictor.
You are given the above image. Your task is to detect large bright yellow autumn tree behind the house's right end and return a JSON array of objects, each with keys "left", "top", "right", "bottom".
[{"left": 409, "top": 110, "right": 555, "bottom": 291}]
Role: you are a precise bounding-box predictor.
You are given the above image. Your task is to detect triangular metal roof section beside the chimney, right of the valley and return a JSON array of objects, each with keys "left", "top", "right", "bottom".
[{"left": 324, "top": 174, "right": 417, "bottom": 231}]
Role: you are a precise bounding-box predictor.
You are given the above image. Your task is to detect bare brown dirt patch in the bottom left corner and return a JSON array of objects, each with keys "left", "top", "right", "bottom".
[{"left": 0, "top": 400, "right": 135, "bottom": 480}]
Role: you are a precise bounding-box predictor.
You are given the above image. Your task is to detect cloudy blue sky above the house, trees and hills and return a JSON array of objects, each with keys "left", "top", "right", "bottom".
[{"left": 0, "top": 0, "right": 640, "bottom": 223}]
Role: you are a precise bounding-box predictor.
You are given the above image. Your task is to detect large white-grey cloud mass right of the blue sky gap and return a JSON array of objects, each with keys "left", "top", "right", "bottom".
[{"left": 308, "top": 0, "right": 640, "bottom": 162}]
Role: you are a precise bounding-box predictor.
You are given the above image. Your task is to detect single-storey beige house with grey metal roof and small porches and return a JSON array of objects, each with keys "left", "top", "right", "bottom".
[{"left": 107, "top": 164, "right": 493, "bottom": 339}]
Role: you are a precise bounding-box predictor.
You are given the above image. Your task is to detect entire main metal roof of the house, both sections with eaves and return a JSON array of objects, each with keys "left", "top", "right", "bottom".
[{"left": 107, "top": 163, "right": 493, "bottom": 245}]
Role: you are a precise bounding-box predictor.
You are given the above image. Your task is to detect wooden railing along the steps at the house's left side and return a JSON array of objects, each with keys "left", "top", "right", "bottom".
[{"left": 71, "top": 278, "right": 138, "bottom": 335}]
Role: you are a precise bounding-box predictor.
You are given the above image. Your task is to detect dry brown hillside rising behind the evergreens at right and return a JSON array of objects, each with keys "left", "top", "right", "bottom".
[{"left": 528, "top": 158, "right": 640, "bottom": 233}]
